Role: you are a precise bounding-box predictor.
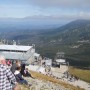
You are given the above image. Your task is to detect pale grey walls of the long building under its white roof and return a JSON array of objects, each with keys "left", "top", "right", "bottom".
[{"left": 0, "top": 47, "right": 35, "bottom": 64}]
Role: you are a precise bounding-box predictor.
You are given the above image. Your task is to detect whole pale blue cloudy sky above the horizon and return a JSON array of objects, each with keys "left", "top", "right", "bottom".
[{"left": 0, "top": 0, "right": 90, "bottom": 21}]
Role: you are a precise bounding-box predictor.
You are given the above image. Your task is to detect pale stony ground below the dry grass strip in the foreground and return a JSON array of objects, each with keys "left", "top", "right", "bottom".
[{"left": 25, "top": 77, "right": 70, "bottom": 90}]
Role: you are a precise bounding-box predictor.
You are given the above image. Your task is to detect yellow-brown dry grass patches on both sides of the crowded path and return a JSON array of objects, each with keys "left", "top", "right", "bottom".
[{"left": 16, "top": 67, "right": 90, "bottom": 90}]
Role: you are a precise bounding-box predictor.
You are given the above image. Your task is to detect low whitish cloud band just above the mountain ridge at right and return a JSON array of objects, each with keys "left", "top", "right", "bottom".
[{"left": 25, "top": 11, "right": 90, "bottom": 21}]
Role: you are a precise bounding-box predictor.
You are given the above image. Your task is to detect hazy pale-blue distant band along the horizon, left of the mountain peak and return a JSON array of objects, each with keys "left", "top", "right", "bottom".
[{"left": 0, "top": 18, "right": 62, "bottom": 31}]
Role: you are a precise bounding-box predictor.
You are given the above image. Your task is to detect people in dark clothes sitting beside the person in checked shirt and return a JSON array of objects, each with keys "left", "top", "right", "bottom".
[{"left": 11, "top": 60, "right": 32, "bottom": 85}]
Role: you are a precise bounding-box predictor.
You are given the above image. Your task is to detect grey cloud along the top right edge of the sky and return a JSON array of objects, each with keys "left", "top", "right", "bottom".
[{"left": 28, "top": 0, "right": 90, "bottom": 9}]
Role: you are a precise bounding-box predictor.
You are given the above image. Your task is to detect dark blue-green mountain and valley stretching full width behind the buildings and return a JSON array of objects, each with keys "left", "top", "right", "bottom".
[{"left": 0, "top": 20, "right": 90, "bottom": 66}]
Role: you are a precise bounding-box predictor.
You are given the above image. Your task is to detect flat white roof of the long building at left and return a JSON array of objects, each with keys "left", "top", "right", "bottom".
[{"left": 0, "top": 45, "right": 33, "bottom": 51}]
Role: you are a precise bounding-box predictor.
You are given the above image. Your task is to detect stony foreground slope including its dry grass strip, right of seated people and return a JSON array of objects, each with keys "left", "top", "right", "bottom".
[{"left": 21, "top": 71, "right": 84, "bottom": 90}]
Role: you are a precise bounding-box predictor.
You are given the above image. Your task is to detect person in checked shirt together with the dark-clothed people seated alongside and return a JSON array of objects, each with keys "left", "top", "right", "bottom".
[{"left": 0, "top": 56, "right": 32, "bottom": 90}]
